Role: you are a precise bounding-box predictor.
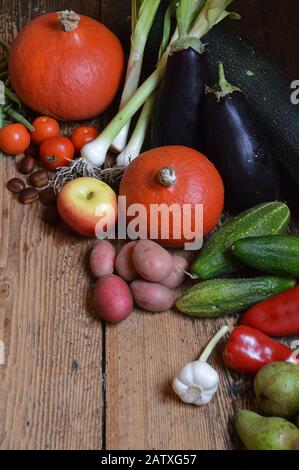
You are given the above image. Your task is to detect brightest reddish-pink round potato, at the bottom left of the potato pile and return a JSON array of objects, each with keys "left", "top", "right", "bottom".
[{"left": 93, "top": 274, "right": 133, "bottom": 323}]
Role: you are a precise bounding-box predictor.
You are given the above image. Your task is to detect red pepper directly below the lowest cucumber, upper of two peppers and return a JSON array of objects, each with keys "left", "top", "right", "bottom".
[{"left": 240, "top": 287, "right": 299, "bottom": 336}]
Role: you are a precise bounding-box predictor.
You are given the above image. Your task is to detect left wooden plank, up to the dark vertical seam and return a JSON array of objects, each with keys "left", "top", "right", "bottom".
[{"left": 0, "top": 1, "right": 102, "bottom": 449}]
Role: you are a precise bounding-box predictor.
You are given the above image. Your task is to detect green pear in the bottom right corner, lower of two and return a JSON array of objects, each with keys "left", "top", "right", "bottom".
[{"left": 235, "top": 410, "right": 299, "bottom": 450}]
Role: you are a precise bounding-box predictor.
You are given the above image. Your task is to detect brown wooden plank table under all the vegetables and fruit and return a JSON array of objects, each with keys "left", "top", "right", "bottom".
[{"left": 0, "top": 0, "right": 299, "bottom": 450}]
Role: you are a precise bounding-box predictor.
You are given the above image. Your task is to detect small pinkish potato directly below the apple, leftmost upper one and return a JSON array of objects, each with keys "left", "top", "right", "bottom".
[{"left": 89, "top": 240, "right": 116, "bottom": 277}]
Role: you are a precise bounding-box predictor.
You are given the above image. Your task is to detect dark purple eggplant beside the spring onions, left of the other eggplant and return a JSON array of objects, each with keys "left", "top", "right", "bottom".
[{"left": 151, "top": 41, "right": 208, "bottom": 149}]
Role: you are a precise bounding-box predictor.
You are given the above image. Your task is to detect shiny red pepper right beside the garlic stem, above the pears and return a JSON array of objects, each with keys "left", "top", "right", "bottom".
[{"left": 223, "top": 326, "right": 297, "bottom": 375}]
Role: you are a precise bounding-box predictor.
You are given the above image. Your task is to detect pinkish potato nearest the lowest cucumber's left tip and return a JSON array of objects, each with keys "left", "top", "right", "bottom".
[{"left": 131, "top": 281, "right": 175, "bottom": 312}]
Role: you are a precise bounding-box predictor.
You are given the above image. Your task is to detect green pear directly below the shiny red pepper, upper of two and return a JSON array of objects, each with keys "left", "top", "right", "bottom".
[{"left": 254, "top": 362, "right": 299, "bottom": 418}]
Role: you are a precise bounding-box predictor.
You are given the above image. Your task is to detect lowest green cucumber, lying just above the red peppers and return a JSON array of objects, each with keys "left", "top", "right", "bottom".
[{"left": 176, "top": 276, "right": 296, "bottom": 318}]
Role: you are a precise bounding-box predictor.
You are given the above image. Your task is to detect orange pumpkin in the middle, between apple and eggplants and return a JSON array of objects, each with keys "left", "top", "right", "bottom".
[{"left": 120, "top": 146, "right": 224, "bottom": 247}]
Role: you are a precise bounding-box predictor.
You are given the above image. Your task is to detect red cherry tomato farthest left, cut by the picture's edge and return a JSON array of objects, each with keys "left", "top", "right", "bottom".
[{"left": 0, "top": 124, "right": 31, "bottom": 155}]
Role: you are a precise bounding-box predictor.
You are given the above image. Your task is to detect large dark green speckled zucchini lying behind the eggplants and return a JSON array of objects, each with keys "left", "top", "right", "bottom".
[{"left": 204, "top": 25, "right": 299, "bottom": 185}]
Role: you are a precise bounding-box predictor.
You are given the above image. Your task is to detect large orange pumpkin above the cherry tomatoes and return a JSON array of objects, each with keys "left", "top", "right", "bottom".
[{"left": 9, "top": 11, "right": 124, "bottom": 120}]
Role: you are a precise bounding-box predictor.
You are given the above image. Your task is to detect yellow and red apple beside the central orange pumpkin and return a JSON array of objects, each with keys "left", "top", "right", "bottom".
[{"left": 57, "top": 178, "right": 117, "bottom": 237}]
